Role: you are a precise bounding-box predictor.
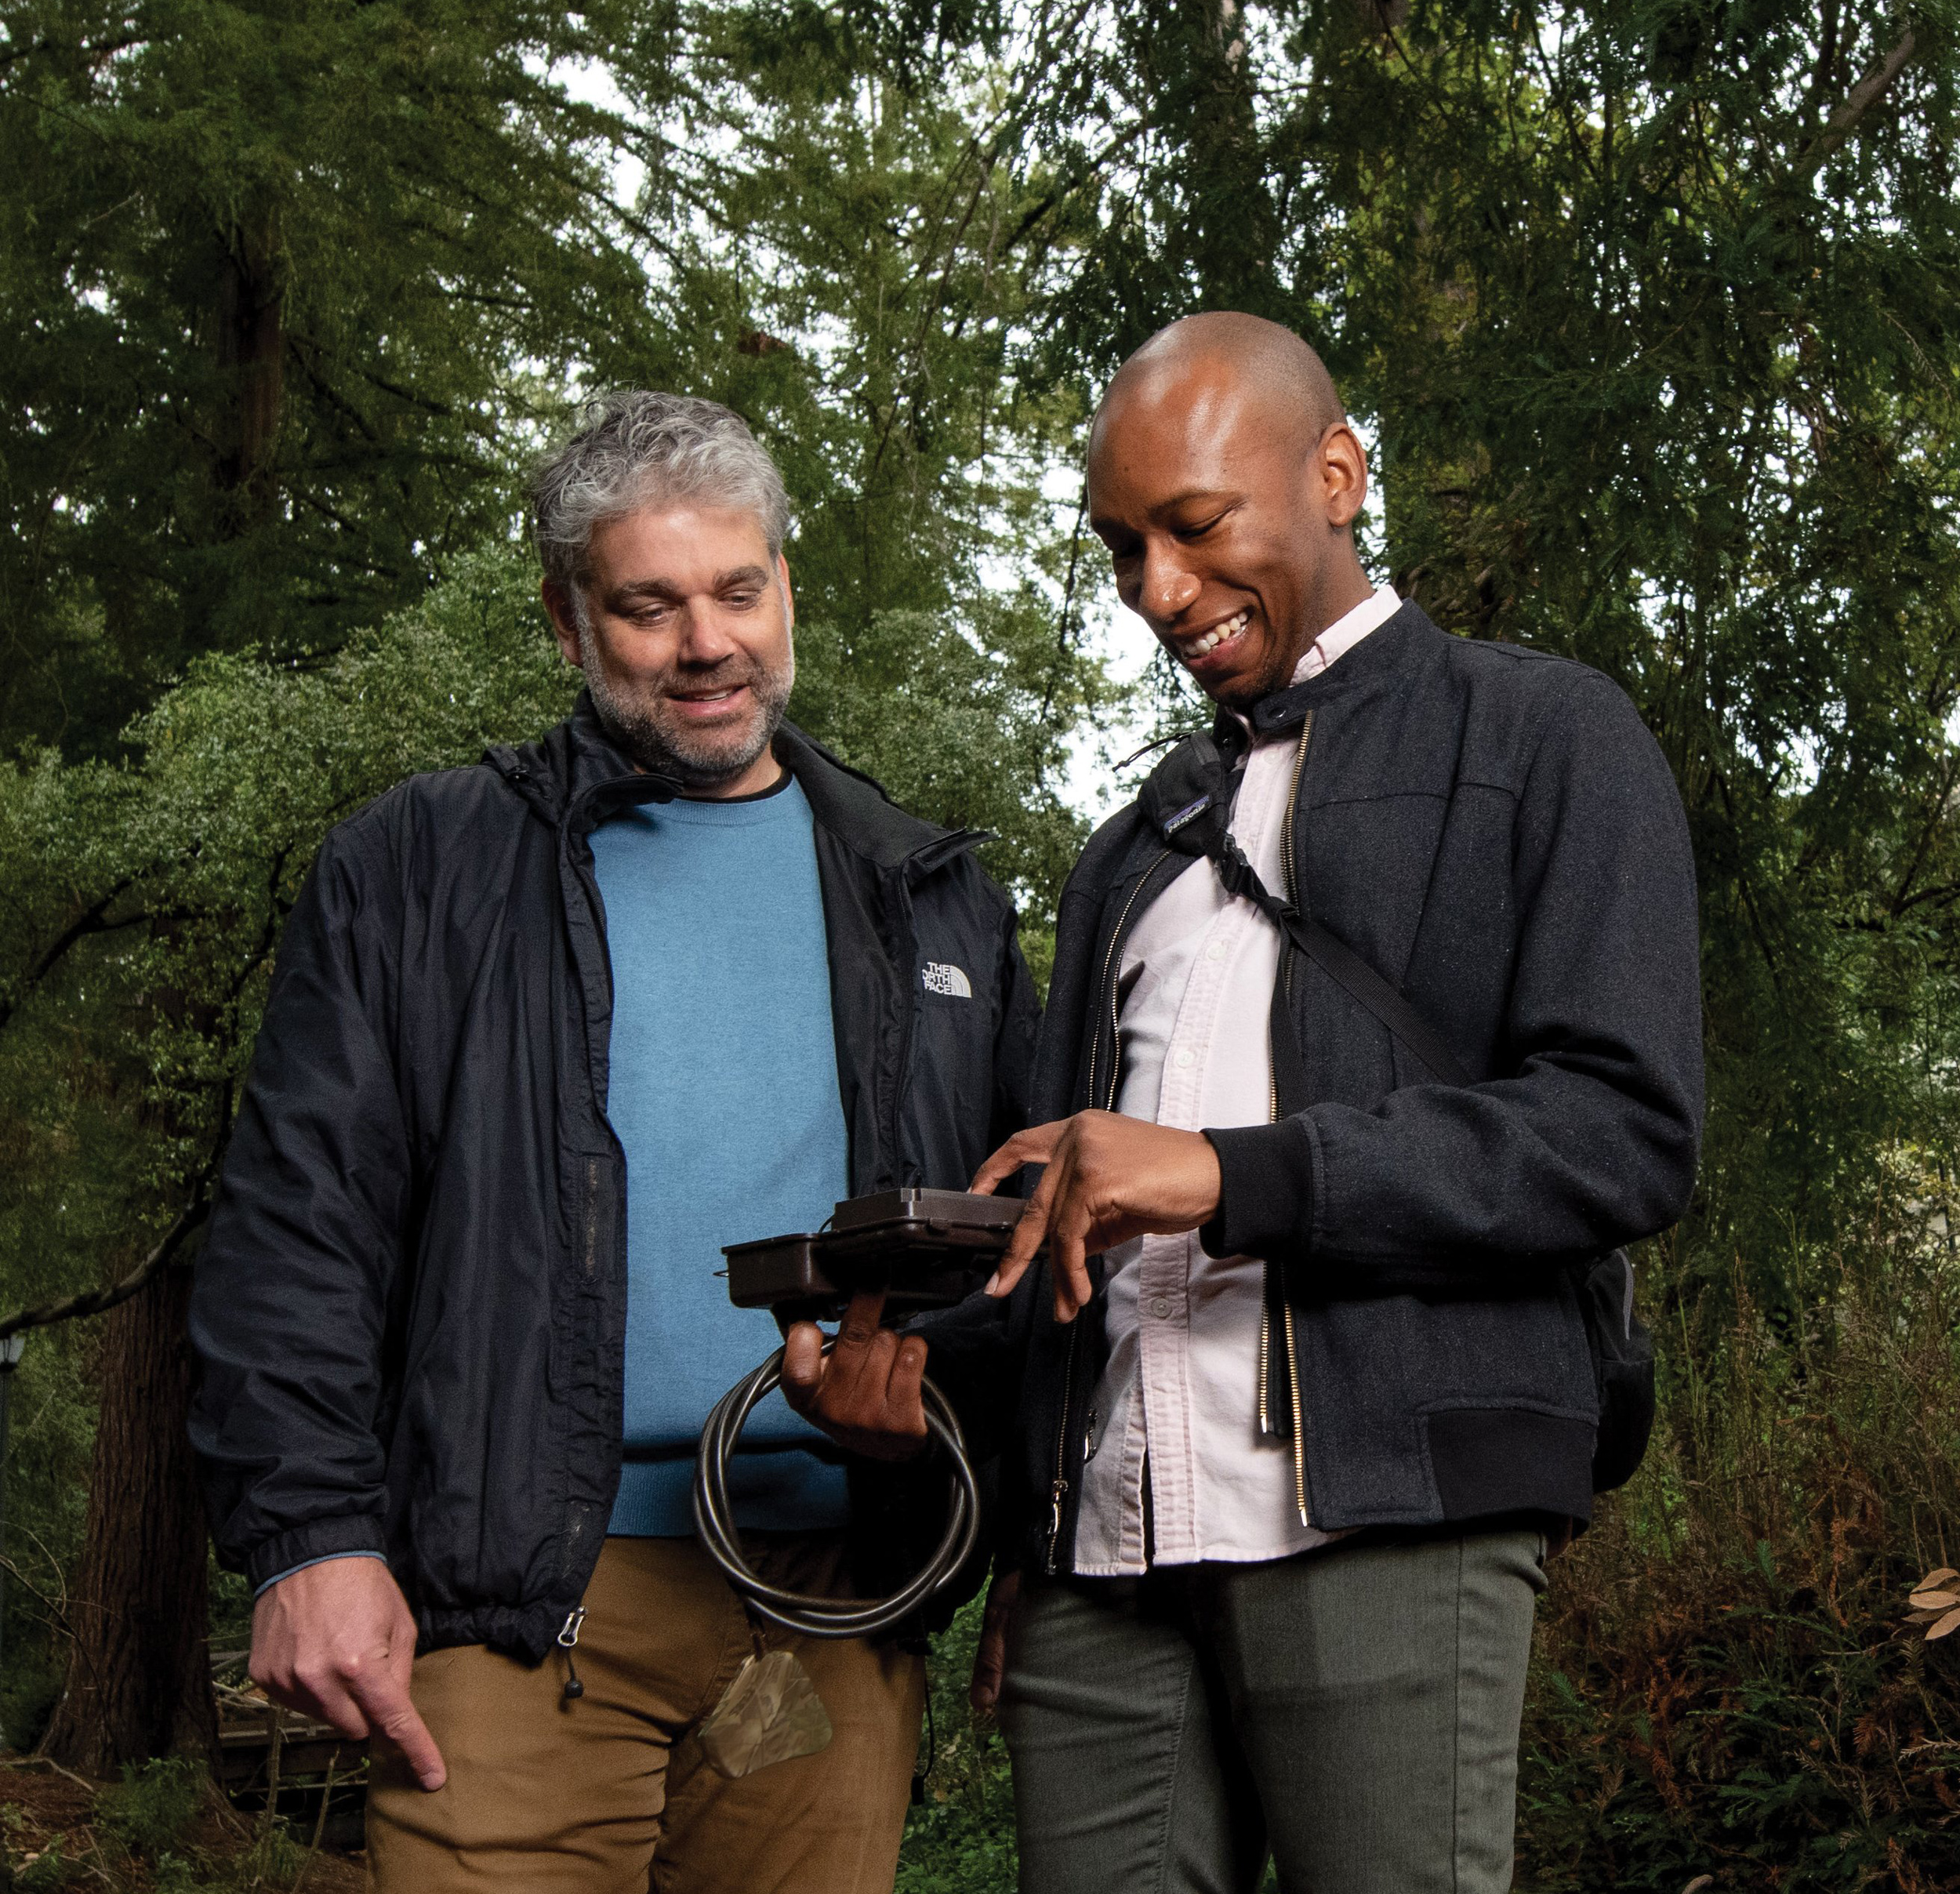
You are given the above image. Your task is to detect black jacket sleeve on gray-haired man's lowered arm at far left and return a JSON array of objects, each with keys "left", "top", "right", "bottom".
[{"left": 191, "top": 825, "right": 410, "bottom": 1586}]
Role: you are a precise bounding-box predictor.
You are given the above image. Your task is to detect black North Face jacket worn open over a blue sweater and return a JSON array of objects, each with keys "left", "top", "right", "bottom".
[{"left": 192, "top": 698, "right": 1037, "bottom": 1659}]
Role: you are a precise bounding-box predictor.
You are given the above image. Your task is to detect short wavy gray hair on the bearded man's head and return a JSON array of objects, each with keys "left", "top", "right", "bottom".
[{"left": 532, "top": 388, "right": 790, "bottom": 614}]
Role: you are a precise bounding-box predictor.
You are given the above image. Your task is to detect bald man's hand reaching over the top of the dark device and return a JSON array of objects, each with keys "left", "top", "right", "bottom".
[{"left": 972, "top": 1112, "right": 1221, "bottom": 1322}]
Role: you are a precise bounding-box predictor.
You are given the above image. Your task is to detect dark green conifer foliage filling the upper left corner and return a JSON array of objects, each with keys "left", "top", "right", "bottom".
[{"left": 0, "top": 0, "right": 659, "bottom": 749}]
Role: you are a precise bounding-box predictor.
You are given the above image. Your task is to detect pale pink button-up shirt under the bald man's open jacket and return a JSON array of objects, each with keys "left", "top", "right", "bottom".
[{"left": 1076, "top": 586, "right": 1402, "bottom": 1578}]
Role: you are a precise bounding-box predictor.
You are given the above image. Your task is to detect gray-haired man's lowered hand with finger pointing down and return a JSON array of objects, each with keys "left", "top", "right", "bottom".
[{"left": 251, "top": 1558, "right": 449, "bottom": 1788}]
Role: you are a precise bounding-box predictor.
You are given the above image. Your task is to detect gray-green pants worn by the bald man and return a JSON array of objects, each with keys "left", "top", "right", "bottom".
[{"left": 1002, "top": 1531, "right": 1544, "bottom": 1894}]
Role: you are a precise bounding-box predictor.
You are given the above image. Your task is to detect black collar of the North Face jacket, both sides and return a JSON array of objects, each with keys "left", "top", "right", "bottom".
[{"left": 485, "top": 690, "right": 986, "bottom": 869}]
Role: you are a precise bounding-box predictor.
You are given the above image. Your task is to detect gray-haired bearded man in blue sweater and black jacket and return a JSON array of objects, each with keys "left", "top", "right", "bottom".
[{"left": 192, "top": 392, "right": 1035, "bottom": 1894}]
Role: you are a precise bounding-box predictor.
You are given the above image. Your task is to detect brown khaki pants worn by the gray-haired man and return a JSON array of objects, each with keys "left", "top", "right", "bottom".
[{"left": 367, "top": 1533, "right": 925, "bottom": 1894}]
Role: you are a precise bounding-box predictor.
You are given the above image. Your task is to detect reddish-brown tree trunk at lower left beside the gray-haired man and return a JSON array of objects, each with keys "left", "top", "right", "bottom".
[{"left": 42, "top": 1267, "right": 218, "bottom": 1776}]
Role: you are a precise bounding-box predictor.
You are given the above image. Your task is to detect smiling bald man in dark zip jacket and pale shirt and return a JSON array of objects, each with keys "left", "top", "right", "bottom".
[{"left": 931, "top": 314, "right": 1701, "bottom": 1894}]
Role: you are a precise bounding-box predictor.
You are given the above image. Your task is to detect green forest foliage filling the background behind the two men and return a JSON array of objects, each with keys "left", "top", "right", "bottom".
[{"left": 0, "top": 0, "right": 1960, "bottom": 1890}]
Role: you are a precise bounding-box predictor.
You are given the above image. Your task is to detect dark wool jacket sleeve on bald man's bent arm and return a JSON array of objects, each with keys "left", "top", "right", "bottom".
[{"left": 1202, "top": 674, "right": 1701, "bottom": 1280}]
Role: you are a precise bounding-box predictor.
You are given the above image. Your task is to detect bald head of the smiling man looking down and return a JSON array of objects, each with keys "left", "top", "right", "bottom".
[{"left": 1088, "top": 314, "right": 1374, "bottom": 708}]
